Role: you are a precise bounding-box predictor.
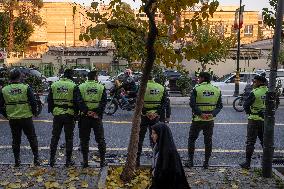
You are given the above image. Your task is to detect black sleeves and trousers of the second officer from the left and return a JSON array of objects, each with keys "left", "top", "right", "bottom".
[{"left": 47, "top": 87, "right": 79, "bottom": 166}]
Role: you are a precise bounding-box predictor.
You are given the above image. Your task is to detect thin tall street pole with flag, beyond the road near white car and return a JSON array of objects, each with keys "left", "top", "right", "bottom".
[{"left": 234, "top": 0, "right": 242, "bottom": 96}]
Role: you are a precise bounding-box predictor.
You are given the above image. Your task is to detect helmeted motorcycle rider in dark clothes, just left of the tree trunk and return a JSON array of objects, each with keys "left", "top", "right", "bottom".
[{"left": 119, "top": 69, "right": 137, "bottom": 108}]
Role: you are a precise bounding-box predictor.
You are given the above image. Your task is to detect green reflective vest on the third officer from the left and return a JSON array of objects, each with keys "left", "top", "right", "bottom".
[{"left": 79, "top": 80, "right": 104, "bottom": 110}]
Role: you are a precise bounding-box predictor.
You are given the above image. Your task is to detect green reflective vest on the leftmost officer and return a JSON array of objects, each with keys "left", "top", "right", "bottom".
[{"left": 2, "top": 83, "right": 33, "bottom": 119}]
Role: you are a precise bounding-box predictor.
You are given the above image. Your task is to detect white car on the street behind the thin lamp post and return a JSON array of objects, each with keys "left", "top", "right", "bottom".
[{"left": 211, "top": 72, "right": 259, "bottom": 95}]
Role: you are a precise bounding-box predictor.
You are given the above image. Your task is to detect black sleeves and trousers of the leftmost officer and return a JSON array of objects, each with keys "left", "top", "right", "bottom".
[{"left": 0, "top": 83, "right": 39, "bottom": 166}]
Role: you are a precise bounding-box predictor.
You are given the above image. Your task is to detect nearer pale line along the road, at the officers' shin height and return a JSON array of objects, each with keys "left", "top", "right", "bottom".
[{"left": 0, "top": 145, "right": 284, "bottom": 154}]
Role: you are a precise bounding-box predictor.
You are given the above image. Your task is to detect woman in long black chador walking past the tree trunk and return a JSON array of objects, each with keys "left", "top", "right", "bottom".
[{"left": 150, "top": 123, "right": 190, "bottom": 189}]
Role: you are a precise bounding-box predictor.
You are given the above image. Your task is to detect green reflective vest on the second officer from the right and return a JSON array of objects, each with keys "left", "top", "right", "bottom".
[{"left": 193, "top": 82, "right": 221, "bottom": 121}]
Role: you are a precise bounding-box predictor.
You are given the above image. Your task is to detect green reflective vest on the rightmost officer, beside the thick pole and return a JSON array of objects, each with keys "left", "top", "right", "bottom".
[{"left": 248, "top": 86, "right": 268, "bottom": 121}]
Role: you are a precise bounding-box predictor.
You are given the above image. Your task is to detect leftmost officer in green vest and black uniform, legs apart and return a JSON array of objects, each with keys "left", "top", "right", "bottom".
[{"left": 0, "top": 69, "right": 40, "bottom": 167}]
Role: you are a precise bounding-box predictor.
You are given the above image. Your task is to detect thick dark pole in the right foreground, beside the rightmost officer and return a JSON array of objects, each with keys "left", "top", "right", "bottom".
[{"left": 262, "top": 0, "right": 284, "bottom": 178}]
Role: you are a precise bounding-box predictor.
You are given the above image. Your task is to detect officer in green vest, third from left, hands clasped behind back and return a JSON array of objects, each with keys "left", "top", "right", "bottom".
[{"left": 78, "top": 71, "right": 107, "bottom": 168}]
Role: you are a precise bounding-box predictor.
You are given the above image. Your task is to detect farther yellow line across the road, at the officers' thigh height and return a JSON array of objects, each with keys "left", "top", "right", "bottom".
[{"left": 0, "top": 119, "right": 284, "bottom": 126}]
